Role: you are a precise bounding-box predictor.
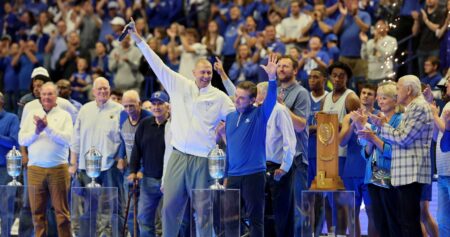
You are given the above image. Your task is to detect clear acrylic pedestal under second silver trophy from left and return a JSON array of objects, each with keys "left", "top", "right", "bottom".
[{"left": 70, "top": 187, "right": 120, "bottom": 237}]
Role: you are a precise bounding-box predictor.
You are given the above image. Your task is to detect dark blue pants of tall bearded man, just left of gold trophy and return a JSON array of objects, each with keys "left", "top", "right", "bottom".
[{"left": 291, "top": 161, "right": 308, "bottom": 236}]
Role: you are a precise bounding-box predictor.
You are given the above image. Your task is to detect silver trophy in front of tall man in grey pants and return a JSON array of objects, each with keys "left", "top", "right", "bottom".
[{"left": 208, "top": 145, "right": 226, "bottom": 190}]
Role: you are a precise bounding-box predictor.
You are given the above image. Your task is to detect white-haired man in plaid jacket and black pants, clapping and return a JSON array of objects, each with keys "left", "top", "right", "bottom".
[{"left": 364, "top": 75, "right": 433, "bottom": 236}]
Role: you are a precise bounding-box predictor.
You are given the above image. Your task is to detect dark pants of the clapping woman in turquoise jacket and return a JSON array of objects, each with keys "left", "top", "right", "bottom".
[{"left": 367, "top": 184, "right": 401, "bottom": 237}]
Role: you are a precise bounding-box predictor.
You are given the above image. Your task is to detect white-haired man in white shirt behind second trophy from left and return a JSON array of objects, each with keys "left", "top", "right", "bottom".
[{"left": 69, "top": 77, "right": 124, "bottom": 236}]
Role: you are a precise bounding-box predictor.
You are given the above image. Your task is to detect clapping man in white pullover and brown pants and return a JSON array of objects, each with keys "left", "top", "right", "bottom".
[{"left": 19, "top": 82, "right": 73, "bottom": 237}]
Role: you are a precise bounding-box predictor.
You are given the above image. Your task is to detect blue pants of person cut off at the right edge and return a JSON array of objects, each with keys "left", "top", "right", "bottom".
[{"left": 437, "top": 176, "right": 450, "bottom": 236}]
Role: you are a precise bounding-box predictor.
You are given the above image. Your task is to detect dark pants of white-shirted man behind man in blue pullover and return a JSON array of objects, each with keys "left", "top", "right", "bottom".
[{"left": 266, "top": 162, "right": 294, "bottom": 237}]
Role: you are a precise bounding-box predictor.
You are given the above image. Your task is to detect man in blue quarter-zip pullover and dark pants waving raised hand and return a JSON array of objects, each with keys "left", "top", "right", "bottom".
[{"left": 225, "top": 54, "right": 277, "bottom": 237}]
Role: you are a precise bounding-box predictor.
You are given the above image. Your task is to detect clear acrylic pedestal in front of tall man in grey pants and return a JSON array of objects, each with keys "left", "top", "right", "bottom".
[{"left": 191, "top": 189, "right": 241, "bottom": 237}]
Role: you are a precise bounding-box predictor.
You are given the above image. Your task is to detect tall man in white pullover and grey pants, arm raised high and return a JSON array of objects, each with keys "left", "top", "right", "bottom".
[{"left": 128, "top": 18, "right": 235, "bottom": 236}]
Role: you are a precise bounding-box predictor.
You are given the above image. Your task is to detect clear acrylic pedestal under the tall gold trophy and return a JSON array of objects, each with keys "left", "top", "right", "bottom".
[{"left": 301, "top": 190, "right": 358, "bottom": 237}]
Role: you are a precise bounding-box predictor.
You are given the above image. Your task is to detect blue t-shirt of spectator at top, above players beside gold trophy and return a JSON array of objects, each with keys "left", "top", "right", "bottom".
[{"left": 339, "top": 11, "right": 371, "bottom": 58}]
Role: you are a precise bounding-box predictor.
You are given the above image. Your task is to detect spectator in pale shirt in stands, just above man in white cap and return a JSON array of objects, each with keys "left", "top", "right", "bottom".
[{"left": 45, "top": 20, "right": 67, "bottom": 71}]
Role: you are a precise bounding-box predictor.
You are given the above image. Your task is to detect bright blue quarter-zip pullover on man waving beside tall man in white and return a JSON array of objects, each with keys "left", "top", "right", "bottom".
[{"left": 225, "top": 81, "right": 277, "bottom": 176}]
